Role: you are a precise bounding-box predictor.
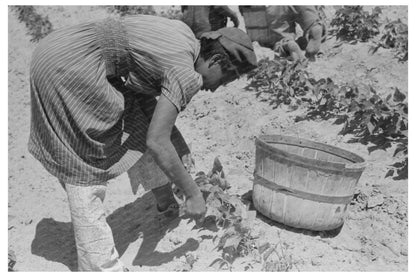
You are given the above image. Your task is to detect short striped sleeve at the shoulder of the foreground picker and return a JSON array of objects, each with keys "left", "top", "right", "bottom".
[{"left": 161, "top": 67, "right": 202, "bottom": 112}]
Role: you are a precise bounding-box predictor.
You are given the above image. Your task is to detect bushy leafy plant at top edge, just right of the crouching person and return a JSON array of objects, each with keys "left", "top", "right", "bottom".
[{"left": 330, "top": 6, "right": 381, "bottom": 43}]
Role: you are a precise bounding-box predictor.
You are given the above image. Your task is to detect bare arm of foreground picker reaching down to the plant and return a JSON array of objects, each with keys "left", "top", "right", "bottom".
[{"left": 146, "top": 94, "right": 206, "bottom": 216}]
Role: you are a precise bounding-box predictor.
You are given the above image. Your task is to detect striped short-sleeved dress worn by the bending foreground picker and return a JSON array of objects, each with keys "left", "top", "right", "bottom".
[{"left": 29, "top": 16, "right": 202, "bottom": 185}]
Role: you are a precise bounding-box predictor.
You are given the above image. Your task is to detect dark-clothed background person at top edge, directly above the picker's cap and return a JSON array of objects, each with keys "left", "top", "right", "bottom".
[{"left": 182, "top": 6, "right": 240, "bottom": 38}]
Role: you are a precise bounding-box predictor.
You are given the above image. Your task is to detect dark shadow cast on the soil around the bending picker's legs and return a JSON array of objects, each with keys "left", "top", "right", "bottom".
[{"left": 31, "top": 192, "right": 199, "bottom": 271}]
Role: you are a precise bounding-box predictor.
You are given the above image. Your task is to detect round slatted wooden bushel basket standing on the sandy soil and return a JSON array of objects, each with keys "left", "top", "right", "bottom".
[{"left": 253, "top": 135, "right": 364, "bottom": 231}]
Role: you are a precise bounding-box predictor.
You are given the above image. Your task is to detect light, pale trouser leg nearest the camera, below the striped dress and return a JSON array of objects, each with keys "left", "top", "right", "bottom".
[{"left": 61, "top": 182, "right": 124, "bottom": 271}]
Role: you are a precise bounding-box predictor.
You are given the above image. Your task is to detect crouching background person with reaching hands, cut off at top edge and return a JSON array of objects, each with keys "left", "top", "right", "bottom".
[{"left": 239, "top": 6, "right": 326, "bottom": 60}]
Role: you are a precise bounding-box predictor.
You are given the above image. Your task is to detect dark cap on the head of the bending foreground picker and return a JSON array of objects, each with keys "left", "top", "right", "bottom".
[{"left": 201, "top": 27, "right": 257, "bottom": 74}]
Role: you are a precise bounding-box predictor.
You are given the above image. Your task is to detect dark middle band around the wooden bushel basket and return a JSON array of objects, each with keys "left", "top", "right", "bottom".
[{"left": 254, "top": 174, "right": 353, "bottom": 204}]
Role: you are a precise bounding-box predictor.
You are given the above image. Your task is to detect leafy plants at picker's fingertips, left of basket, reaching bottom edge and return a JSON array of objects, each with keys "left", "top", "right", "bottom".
[{"left": 195, "top": 158, "right": 293, "bottom": 271}]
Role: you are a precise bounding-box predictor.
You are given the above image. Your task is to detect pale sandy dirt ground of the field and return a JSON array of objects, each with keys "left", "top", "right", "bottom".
[{"left": 8, "top": 6, "right": 408, "bottom": 271}]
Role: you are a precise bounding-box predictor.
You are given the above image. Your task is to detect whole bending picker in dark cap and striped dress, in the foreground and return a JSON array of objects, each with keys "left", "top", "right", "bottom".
[{"left": 28, "top": 15, "right": 257, "bottom": 271}]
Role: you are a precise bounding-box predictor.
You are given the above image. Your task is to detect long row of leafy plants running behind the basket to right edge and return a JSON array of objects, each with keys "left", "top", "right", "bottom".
[{"left": 246, "top": 59, "right": 408, "bottom": 179}]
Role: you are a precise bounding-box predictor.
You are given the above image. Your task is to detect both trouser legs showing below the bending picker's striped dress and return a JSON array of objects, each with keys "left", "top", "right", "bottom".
[{"left": 60, "top": 151, "right": 184, "bottom": 271}]
